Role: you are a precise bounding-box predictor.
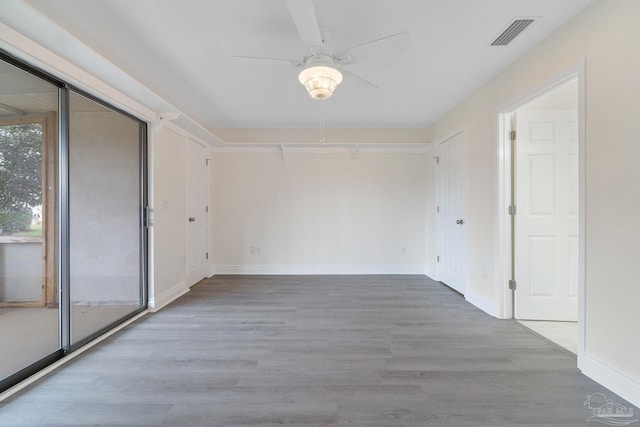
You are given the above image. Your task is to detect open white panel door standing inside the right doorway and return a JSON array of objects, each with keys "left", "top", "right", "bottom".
[{"left": 514, "top": 111, "right": 578, "bottom": 321}]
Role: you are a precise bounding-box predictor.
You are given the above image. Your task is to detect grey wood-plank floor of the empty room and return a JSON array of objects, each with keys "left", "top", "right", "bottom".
[{"left": 0, "top": 276, "right": 629, "bottom": 427}]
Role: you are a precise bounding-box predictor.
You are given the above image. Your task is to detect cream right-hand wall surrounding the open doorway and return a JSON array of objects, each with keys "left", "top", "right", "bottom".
[{"left": 430, "top": 0, "right": 640, "bottom": 405}]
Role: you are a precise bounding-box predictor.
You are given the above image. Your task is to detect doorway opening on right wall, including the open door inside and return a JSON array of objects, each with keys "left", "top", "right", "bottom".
[{"left": 499, "top": 68, "right": 585, "bottom": 359}]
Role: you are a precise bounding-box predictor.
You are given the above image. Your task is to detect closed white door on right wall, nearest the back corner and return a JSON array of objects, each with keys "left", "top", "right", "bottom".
[{"left": 436, "top": 133, "right": 467, "bottom": 294}]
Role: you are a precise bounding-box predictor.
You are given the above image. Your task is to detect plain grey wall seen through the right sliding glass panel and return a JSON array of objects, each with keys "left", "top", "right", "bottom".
[{"left": 69, "top": 110, "right": 140, "bottom": 306}]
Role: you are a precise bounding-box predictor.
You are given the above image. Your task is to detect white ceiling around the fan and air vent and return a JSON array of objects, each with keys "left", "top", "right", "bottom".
[{"left": 12, "top": 0, "right": 591, "bottom": 144}]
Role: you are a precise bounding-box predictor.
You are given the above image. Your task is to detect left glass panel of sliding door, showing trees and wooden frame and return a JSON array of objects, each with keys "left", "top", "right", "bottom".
[{"left": 0, "top": 55, "right": 60, "bottom": 389}]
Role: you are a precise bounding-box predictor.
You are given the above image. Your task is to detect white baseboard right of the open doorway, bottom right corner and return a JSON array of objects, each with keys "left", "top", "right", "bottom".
[{"left": 579, "top": 353, "right": 640, "bottom": 408}]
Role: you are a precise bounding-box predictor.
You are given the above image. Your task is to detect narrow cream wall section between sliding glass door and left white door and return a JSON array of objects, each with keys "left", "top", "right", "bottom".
[{"left": 149, "top": 127, "right": 188, "bottom": 310}]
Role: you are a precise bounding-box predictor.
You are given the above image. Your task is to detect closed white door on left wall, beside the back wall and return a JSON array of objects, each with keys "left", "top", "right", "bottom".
[{"left": 186, "top": 142, "right": 209, "bottom": 286}]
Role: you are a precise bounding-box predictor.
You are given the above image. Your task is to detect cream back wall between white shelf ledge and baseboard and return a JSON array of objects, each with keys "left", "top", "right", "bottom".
[{"left": 212, "top": 151, "right": 433, "bottom": 274}]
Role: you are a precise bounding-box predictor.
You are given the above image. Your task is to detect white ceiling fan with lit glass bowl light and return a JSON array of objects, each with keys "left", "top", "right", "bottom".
[{"left": 232, "top": 0, "right": 409, "bottom": 99}]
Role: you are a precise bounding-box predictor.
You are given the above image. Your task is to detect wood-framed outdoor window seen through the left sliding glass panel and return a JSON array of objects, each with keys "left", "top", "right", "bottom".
[{"left": 0, "top": 113, "right": 56, "bottom": 306}]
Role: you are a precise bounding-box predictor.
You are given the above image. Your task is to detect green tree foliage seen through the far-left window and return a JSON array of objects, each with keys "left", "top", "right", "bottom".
[{"left": 0, "top": 123, "right": 42, "bottom": 232}]
